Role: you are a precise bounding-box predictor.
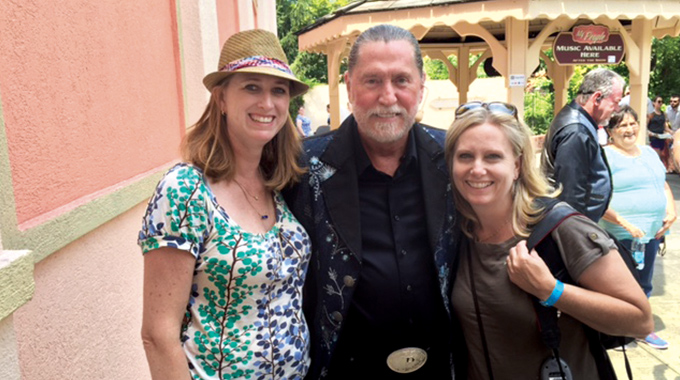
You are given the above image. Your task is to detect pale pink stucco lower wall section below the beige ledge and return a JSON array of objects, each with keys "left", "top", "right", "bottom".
[{"left": 14, "top": 204, "right": 150, "bottom": 380}]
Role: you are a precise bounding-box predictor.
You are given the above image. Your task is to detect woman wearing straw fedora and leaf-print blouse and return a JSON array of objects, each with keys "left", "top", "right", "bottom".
[{"left": 139, "top": 30, "right": 310, "bottom": 380}]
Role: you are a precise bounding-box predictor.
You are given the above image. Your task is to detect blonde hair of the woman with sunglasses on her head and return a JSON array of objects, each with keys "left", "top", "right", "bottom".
[{"left": 445, "top": 107, "right": 559, "bottom": 238}]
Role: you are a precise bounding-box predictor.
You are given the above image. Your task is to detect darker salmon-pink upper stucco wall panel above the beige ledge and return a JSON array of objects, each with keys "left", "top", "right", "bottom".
[{"left": 0, "top": 0, "right": 185, "bottom": 228}]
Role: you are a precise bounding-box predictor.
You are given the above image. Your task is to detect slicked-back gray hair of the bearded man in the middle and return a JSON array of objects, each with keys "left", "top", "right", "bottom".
[{"left": 347, "top": 24, "right": 423, "bottom": 74}]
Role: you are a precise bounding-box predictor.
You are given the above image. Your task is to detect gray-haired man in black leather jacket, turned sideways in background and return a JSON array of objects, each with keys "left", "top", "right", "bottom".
[{"left": 541, "top": 69, "right": 625, "bottom": 222}]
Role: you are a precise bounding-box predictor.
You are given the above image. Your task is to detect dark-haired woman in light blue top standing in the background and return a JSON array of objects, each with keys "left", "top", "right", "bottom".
[{"left": 600, "top": 106, "right": 676, "bottom": 349}]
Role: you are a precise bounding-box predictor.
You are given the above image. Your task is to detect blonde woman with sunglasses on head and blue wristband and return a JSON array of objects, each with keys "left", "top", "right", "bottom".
[{"left": 445, "top": 102, "right": 652, "bottom": 380}]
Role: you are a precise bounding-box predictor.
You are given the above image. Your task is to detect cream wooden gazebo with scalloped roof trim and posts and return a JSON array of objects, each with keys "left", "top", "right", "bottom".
[{"left": 298, "top": 0, "right": 680, "bottom": 133}]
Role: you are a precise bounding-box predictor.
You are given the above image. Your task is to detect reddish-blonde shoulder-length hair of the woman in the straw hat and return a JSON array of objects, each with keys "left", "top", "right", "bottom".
[{"left": 182, "top": 77, "right": 303, "bottom": 190}]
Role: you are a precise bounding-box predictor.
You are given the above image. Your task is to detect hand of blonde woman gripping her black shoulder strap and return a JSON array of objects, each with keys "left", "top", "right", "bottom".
[{"left": 506, "top": 240, "right": 556, "bottom": 300}]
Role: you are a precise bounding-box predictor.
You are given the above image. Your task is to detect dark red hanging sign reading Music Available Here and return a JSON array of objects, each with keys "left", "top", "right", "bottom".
[{"left": 553, "top": 25, "right": 625, "bottom": 65}]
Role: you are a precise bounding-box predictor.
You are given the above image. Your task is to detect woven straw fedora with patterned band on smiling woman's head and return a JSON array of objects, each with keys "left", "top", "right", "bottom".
[{"left": 203, "top": 29, "right": 309, "bottom": 98}]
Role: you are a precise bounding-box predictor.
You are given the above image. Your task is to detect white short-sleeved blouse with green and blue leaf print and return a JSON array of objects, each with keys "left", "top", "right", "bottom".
[{"left": 138, "top": 164, "right": 311, "bottom": 379}]
